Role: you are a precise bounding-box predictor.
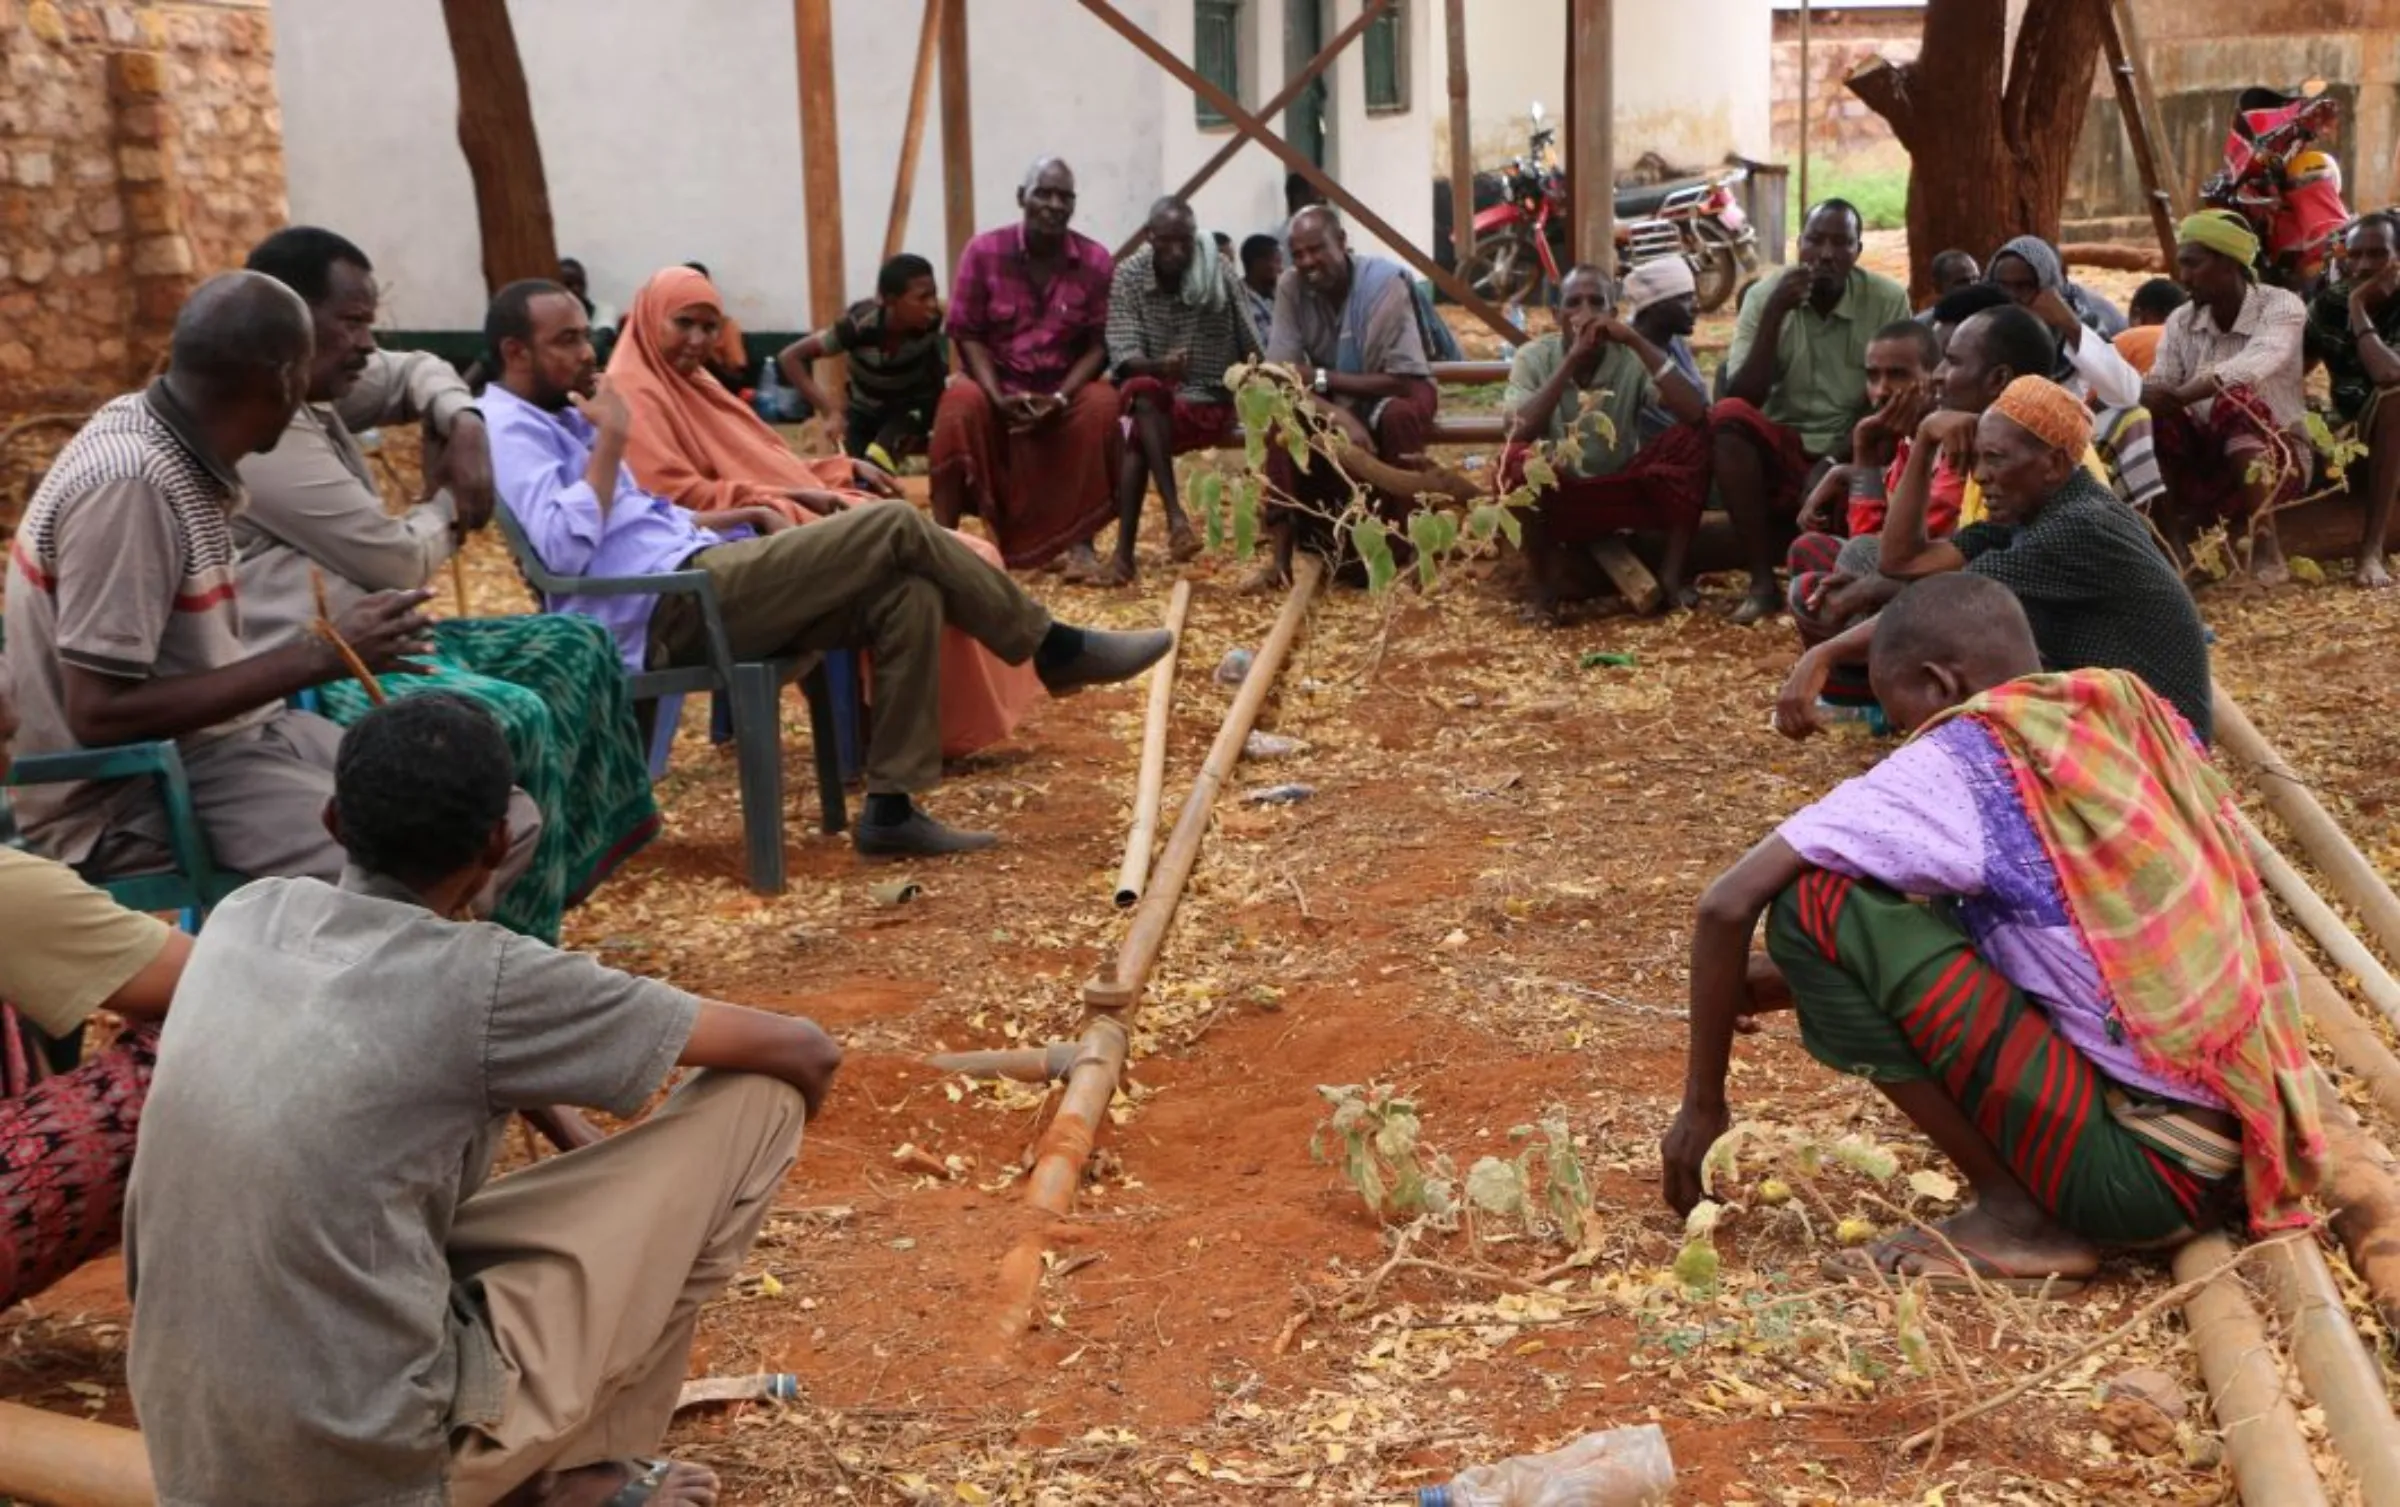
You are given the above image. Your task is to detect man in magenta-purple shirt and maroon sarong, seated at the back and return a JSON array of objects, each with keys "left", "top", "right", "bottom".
[{"left": 931, "top": 158, "right": 1123, "bottom": 578}]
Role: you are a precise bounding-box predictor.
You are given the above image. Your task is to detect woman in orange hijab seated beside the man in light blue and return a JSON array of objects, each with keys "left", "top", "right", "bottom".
[{"left": 607, "top": 266, "right": 1042, "bottom": 758}]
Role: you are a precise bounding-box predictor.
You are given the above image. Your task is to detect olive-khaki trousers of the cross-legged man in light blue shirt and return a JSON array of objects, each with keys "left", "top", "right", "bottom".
[{"left": 650, "top": 502, "right": 1051, "bottom": 794}]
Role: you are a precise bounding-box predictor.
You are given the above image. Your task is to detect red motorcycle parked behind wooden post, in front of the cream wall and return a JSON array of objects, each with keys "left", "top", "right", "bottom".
[{"left": 1462, "top": 101, "right": 1759, "bottom": 312}]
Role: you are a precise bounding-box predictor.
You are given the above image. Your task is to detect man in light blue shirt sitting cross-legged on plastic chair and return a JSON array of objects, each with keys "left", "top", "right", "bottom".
[{"left": 482, "top": 281, "right": 1174, "bottom": 857}]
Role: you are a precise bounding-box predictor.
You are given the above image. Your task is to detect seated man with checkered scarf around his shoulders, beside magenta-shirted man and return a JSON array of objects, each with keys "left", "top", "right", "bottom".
[{"left": 1092, "top": 197, "right": 1258, "bottom": 586}]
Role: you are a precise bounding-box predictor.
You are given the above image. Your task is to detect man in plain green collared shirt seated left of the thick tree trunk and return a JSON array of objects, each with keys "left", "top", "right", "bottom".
[{"left": 1711, "top": 199, "right": 1910, "bottom": 624}]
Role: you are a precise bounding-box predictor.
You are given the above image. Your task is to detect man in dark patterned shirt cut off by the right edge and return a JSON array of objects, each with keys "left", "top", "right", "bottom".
[{"left": 2302, "top": 211, "right": 2400, "bottom": 588}]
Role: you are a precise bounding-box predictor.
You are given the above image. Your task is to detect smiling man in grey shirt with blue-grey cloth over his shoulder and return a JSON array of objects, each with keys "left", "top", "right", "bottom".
[{"left": 1248, "top": 204, "right": 1440, "bottom": 588}]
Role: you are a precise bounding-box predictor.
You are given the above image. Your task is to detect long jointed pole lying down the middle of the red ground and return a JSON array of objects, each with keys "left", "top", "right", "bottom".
[{"left": 994, "top": 552, "right": 1325, "bottom": 1349}]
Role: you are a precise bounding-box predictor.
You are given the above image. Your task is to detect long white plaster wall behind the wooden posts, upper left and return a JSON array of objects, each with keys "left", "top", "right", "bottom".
[{"left": 274, "top": 0, "right": 1430, "bottom": 329}]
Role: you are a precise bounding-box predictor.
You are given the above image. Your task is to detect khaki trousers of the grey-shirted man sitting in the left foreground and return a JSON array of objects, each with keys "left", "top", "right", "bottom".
[{"left": 449, "top": 1073, "right": 806, "bottom": 1507}]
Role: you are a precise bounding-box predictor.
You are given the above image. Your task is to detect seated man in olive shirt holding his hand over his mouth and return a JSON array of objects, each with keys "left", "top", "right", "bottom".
[{"left": 1502, "top": 264, "right": 1709, "bottom": 622}]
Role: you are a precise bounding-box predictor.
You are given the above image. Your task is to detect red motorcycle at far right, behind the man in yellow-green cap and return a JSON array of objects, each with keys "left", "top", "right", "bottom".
[{"left": 2201, "top": 79, "right": 2350, "bottom": 295}]
